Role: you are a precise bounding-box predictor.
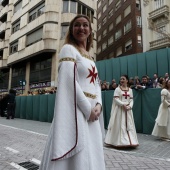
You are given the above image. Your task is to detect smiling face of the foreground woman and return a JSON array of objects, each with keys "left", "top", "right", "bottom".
[{"left": 73, "top": 17, "right": 91, "bottom": 43}]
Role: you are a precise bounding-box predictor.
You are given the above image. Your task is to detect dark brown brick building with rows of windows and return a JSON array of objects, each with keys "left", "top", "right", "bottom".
[{"left": 97, "top": 0, "right": 143, "bottom": 60}]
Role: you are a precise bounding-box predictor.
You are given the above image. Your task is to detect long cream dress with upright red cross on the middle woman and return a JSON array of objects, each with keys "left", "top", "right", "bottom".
[{"left": 105, "top": 86, "right": 139, "bottom": 147}]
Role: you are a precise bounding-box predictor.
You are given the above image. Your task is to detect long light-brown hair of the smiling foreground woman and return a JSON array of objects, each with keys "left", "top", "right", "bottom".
[{"left": 64, "top": 15, "right": 93, "bottom": 51}]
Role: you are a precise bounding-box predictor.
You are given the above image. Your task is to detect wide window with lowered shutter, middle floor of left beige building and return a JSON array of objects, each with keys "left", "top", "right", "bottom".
[{"left": 26, "top": 28, "right": 43, "bottom": 46}]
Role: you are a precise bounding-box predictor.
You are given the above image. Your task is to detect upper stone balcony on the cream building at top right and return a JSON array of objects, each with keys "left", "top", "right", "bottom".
[{"left": 149, "top": 5, "right": 169, "bottom": 21}]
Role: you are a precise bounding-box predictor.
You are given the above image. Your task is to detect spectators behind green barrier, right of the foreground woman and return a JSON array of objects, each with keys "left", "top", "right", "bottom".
[{"left": 101, "top": 73, "right": 170, "bottom": 91}]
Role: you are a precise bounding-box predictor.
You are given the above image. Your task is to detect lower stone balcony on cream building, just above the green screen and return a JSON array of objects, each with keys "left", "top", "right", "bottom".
[{"left": 150, "top": 37, "right": 170, "bottom": 50}]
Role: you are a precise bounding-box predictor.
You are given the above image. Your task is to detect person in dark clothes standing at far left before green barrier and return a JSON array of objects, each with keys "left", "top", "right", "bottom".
[{"left": 7, "top": 89, "right": 16, "bottom": 119}]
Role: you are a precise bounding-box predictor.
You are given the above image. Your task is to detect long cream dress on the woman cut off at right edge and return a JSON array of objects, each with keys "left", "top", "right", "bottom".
[{"left": 152, "top": 89, "right": 170, "bottom": 139}]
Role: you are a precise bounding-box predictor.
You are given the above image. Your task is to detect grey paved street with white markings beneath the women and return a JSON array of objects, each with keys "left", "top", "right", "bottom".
[{"left": 0, "top": 117, "right": 170, "bottom": 170}]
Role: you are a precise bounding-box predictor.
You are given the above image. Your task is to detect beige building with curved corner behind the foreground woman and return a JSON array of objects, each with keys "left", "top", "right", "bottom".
[{"left": 0, "top": 0, "right": 97, "bottom": 93}]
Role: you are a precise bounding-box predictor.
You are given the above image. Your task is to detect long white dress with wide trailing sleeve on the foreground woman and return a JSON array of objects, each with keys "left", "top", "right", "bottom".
[{"left": 40, "top": 44, "right": 105, "bottom": 170}]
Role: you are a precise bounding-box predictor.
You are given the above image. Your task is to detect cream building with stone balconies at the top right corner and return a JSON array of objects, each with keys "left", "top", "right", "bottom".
[{"left": 142, "top": 0, "right": 170, "bottom": 52}]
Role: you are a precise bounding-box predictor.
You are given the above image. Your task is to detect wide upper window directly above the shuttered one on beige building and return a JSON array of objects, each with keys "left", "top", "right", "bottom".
[{"left": 29, "top": 3, "right": 45, "bottom": 22}]
